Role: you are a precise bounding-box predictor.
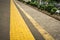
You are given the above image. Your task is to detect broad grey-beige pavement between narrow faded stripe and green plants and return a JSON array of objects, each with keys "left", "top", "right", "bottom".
[{"left": 16, "top": 1, "right": 60, "bottom": 40}]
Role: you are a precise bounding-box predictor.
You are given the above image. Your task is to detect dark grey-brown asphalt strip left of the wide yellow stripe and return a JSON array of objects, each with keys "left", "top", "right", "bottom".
[{"left": 0, "top": 0, "right": 10, "bottom": 40}]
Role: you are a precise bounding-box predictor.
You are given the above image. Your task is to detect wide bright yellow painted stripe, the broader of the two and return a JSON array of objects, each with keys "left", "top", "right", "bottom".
[{"left": 10, "top": 0, "right": 35, "bottom": 40}]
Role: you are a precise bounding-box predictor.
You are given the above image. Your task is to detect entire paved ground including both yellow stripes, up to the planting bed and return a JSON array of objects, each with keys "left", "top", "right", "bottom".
[{"left": 0, "top": 0, "right": 60, "bottom": 40}]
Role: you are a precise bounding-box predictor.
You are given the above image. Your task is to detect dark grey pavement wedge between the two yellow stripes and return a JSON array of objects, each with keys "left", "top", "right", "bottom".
[{"left": 17, "top": 7, "right": 45, "bottom": 40}]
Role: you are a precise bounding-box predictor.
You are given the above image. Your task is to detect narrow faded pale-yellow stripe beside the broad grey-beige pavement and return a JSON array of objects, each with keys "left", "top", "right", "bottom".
[{"left": 15, "top": 1, "right": 55, "bottom": 40}]
